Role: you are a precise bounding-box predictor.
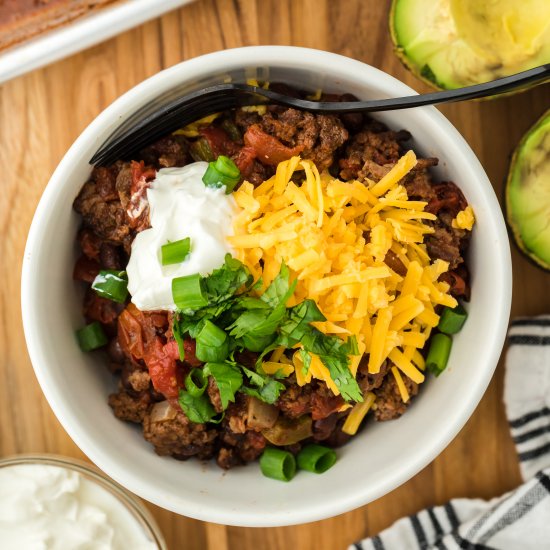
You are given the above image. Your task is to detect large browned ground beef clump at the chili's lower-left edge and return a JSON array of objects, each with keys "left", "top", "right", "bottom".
[{"left": 143, "top": 411, "right": 217, "bottom": 460}]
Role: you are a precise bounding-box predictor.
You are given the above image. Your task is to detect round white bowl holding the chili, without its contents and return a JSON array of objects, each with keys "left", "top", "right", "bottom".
[{"left": 22, "top": 46, "right": 511, "bottom": 526}]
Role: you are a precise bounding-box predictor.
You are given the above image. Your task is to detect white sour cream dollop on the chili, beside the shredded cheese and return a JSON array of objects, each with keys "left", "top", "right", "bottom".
[{"left": 126, "top": 162, "right": 237, "bottom": 311}]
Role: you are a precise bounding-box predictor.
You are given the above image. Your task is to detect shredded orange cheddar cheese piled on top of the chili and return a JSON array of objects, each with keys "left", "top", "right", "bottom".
[{"left": 234, "top": 151, "right": 473, "bottom": 408}]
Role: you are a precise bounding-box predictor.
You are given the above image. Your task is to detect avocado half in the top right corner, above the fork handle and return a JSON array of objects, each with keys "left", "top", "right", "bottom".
[{"left": 390, "top": 0, "right": 550, "bottom": 89}]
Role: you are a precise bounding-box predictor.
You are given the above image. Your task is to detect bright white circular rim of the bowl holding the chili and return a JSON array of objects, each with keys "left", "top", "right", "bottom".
[{"left": 21, "top": 46, "right": 512, "bottom": 527}]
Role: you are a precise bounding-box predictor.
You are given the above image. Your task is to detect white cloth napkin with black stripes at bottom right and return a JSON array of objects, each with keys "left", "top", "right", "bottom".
[{"left": 349, "top": 315, "right": 550, "bottom": 550}]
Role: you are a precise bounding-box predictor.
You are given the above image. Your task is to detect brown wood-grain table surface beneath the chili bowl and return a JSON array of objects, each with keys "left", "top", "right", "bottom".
[{"left": 0, "top": 0, "right": 550, "bottom": 550}]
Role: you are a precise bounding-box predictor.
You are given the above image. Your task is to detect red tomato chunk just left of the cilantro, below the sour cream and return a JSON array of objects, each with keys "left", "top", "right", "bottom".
[{"left": 144, "top": 337, "right": 183, "bottom": 399}]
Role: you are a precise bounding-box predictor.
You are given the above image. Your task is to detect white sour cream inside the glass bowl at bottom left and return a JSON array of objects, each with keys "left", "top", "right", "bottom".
[{"left": 0, "top": 464, "right": 158, "bottom": 550}]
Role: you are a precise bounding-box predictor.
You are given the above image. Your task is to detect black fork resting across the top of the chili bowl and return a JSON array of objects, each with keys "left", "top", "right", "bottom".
[{"left": 90, "top": 64, "right": 550, "bottom": 166}]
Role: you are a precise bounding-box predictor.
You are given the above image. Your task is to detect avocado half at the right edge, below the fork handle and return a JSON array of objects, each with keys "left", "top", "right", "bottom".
[{"left": 505, "top": 109, "right": 550, "bottom": 270}]
